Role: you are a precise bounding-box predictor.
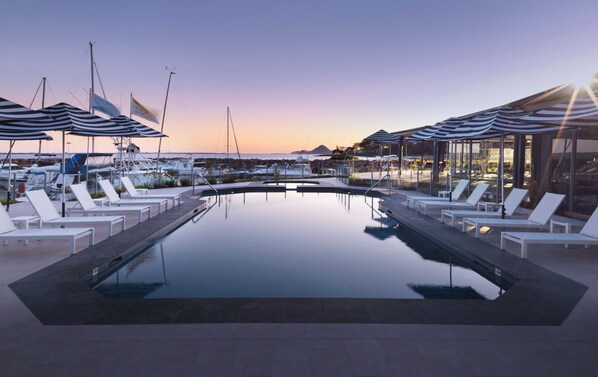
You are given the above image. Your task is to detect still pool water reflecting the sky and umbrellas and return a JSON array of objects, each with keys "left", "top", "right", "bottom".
[{"left": 94, "top": 191, "right": 502, "bottom": 299}]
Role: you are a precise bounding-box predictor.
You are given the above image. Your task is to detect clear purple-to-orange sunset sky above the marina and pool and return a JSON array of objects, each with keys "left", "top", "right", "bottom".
[{"left": 0, "top": 0, "right": 598, "bottom": 153}]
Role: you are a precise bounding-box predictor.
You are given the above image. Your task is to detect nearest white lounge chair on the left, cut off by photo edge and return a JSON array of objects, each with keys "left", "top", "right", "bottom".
[{"left": 0, "top": 206, "right": 93, "bottom": 254}]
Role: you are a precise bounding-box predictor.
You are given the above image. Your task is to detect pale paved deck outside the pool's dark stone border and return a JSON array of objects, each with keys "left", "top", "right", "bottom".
[{"left": 0, "top": 180, "right": 598, "bottom": 376}]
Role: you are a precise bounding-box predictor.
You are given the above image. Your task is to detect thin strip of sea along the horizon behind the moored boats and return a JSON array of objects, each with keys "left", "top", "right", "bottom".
[{"left": 12, "top": 152, "right": 330, "bottom": 161}]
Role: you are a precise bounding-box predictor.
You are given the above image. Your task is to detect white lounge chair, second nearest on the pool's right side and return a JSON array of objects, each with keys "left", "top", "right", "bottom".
[{"left": 463, "top": 192, "right": 565, "bottom": 238}]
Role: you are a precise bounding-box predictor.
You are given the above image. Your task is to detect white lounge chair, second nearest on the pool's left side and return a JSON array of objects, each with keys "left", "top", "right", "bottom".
[{"left": 25, "top": 190, "right": 125, "bottom": 237}]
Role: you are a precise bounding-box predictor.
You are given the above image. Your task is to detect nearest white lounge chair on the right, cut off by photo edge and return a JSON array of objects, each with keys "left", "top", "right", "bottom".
[{"left": 500, "top": 207, "right": 598, "bottom": 258}]
